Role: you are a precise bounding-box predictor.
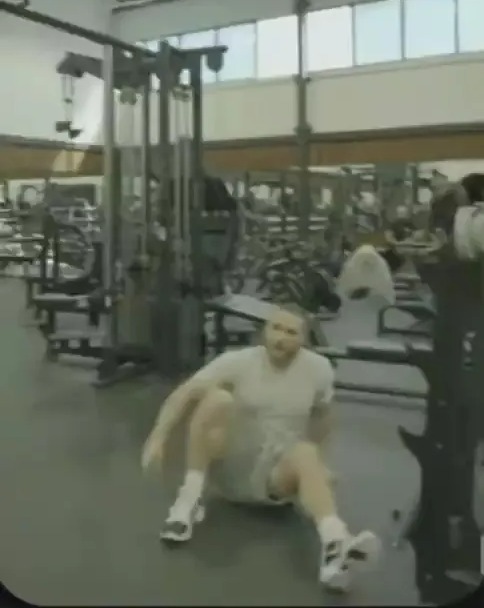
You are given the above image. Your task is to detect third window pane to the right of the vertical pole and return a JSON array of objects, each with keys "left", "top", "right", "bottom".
[{"left": 404, "top": 0, "right": 458, "bottom": 59}]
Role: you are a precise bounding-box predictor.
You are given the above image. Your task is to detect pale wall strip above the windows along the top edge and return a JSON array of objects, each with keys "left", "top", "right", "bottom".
[{"left": 113, "top": 0, "right": 372, "bottom": 42}]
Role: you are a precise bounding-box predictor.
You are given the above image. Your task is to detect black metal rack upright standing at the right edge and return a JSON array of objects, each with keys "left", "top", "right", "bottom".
[{"left": 400, "top": 251, "right": 484, "bottom": 605}]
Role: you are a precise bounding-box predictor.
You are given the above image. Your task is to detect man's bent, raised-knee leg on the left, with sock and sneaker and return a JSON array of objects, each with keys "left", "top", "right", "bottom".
[{"left": 161, "top": 388, "right": 233, "bottom": 542}]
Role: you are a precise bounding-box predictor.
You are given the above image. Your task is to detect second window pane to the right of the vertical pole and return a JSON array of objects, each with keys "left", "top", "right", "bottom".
[{"left": 354, "top": 0, "right": 402, "bottom": 65}]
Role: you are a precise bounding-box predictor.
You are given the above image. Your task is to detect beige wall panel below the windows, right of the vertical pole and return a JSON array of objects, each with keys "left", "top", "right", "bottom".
[{"left": 309, "top": 53, "right": 484, "bottom": 133}]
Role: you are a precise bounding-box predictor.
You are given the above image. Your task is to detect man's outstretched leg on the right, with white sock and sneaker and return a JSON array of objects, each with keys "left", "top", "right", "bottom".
[{"left": 270, "top": 441, "right": 379, "bottom": 591}]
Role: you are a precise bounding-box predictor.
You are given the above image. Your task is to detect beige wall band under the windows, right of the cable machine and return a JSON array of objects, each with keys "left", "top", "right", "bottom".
[{"left": 198, "top": 53, "right": 484, "bottom": 141}]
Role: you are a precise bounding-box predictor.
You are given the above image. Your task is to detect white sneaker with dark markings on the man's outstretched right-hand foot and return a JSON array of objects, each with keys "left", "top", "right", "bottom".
[{"left": 319, "top": 531, "right": 381, "bottom": 593}]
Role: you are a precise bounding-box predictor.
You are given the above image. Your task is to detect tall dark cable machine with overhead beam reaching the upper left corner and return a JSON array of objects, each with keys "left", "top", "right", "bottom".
[{"left": 0, "top": 0, "right": 227, "bottom": 386}]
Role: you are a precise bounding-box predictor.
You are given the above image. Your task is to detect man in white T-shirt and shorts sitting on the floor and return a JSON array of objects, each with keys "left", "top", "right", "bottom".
[{"left": 142, "top": 309, "right": 379, "bottom": 591}]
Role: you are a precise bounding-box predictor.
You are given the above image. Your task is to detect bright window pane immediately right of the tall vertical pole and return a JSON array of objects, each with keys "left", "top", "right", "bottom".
[{"left": 307, "top": 6, "right": 353, "bottom": 72}]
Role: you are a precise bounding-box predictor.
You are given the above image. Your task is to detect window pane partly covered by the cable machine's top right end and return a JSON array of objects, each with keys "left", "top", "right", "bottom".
[{"left": 218, "top": 23, "right": 256, "bottom": 81}]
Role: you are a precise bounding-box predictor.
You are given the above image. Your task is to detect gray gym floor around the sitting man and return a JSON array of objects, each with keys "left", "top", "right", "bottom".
[{"left": 0, "top": 279, "right": 480, "bottom": 606}]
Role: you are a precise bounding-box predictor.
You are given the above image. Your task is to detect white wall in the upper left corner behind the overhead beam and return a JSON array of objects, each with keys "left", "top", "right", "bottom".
[{"left": 0, "top": 0, "right": 111, "bottom": 143}]
